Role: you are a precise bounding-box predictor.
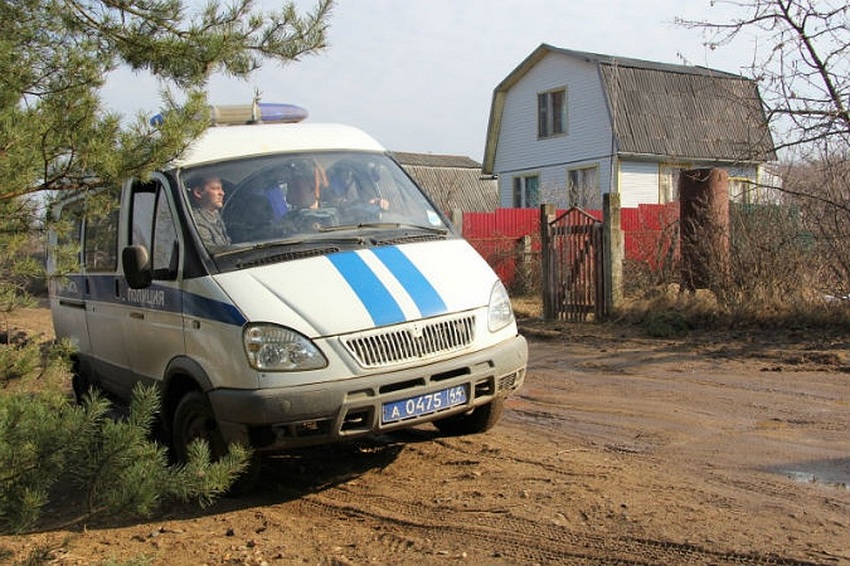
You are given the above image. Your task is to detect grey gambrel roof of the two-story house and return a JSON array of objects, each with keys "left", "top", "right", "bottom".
[{"left": 483, "top": 43, "right": 775, "bottom": 172}]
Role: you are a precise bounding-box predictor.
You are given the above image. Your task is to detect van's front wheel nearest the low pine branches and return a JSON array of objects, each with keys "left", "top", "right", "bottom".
[{"left": 171, "top": 391, "right": 227, "bottom": 462}]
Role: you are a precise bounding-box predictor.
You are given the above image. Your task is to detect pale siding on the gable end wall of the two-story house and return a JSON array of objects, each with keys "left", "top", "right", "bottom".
[{"left": 494, "top": 53, "right": 611, "bottom": 206}]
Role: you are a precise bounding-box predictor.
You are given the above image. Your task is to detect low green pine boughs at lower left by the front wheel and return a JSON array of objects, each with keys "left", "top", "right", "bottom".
[{"left": 0, "top": 386, "right": 250, "bottom": 532}]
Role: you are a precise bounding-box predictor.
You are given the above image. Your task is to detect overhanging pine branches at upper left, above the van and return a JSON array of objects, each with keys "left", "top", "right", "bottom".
[{"left": 0, "top": 0, "right": 332, "bottom": 200}]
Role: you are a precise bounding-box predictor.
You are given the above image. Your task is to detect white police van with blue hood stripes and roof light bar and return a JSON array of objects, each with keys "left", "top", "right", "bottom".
[{"left": 48, "top": 104, "right": 527, "bottom": 464}]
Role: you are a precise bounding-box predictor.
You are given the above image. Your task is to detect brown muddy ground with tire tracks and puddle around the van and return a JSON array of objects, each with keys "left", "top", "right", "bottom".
[{"left": 0, "top": 310, "right": 850, "bottom": 566}]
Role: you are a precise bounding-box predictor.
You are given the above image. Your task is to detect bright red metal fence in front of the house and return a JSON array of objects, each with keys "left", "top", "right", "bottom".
[{"left": 463, "top": 203, "right": 679, "bottom": 287}]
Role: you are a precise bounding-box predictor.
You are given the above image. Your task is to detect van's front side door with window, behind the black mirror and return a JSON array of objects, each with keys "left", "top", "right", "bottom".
[{"left": 124, "top": 180, "right": 185, "bottom": 392}]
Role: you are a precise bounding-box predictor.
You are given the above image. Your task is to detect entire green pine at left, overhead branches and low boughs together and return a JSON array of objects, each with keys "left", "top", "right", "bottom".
[{"left": 0, "top": 0, "right": 333, "bottom": 532}]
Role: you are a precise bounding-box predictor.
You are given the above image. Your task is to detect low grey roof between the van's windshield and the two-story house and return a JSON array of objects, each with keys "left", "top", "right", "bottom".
[{"left": 390, "top": 151, "right": 499, "bottom": 213}]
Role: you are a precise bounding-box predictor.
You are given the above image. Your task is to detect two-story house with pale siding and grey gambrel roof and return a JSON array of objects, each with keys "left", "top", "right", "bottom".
[{"left": 483, "top": 44, "right": 776, "bottom": 208}]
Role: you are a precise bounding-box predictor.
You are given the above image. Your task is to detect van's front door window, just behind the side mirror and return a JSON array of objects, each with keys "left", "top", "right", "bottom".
[{"left": 130, "top": 181, "right": 179, "bottom": 279}]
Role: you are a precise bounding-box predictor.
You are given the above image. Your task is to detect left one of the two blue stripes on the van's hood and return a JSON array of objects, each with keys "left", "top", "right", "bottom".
[{"left": 328, "top": 252, "right": 405, "bottom": 326}]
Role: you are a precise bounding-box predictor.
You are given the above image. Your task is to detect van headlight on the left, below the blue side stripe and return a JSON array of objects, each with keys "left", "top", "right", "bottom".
[{"left": 242, "top": 324, "right": 328, "bottom": 371}]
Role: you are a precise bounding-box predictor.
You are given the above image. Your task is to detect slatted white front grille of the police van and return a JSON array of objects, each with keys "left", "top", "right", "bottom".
[{"left": 342, "top": 315, "right": 475, "bottom": 368}]
